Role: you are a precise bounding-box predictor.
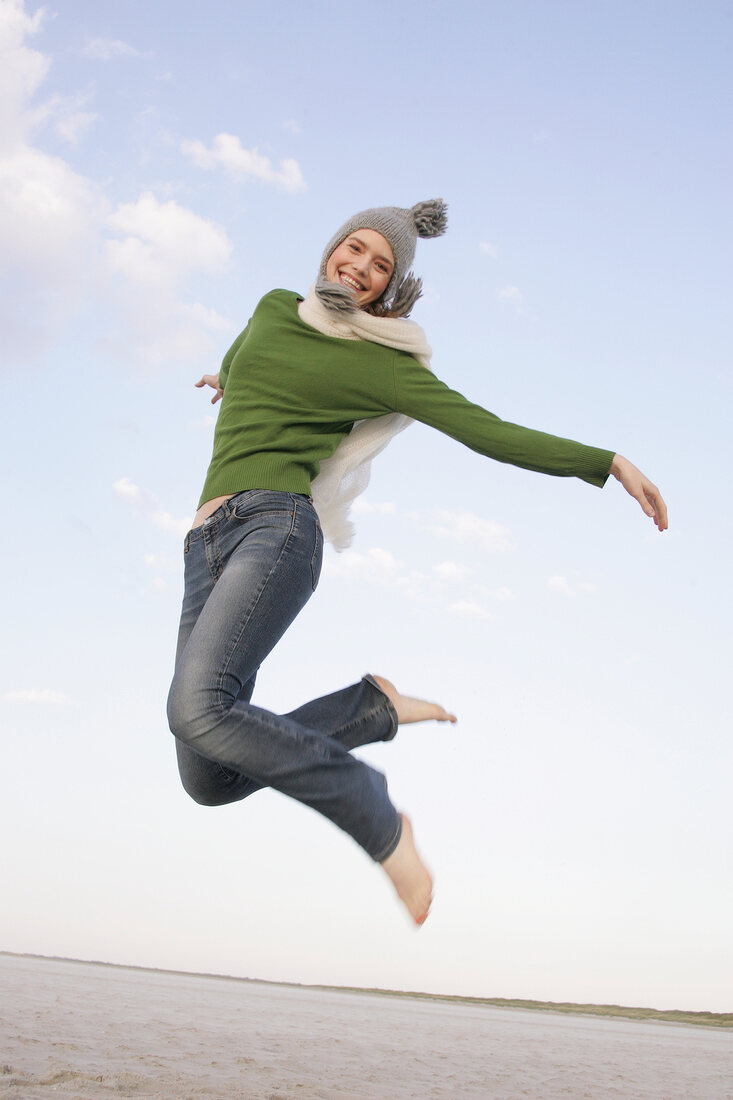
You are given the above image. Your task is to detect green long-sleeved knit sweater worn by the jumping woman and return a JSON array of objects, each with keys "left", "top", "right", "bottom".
[{"left": 199, "top": 290, "right": 614, "bottom": 504}]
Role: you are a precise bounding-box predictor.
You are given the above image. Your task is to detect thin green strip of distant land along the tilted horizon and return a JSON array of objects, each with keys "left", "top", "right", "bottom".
[{"left": 0, "top": 950, "right": 733, "bottom": 1027}]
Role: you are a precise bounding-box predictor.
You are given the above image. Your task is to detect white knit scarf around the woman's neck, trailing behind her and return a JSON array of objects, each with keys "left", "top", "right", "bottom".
[{"left": 298, "top": 287, "right": 431, "bottom": 550}]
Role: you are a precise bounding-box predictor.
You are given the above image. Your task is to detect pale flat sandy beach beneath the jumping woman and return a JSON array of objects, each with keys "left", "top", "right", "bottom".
[{"left": 0, "top": 955, "right": 733, "bottom": 1100}]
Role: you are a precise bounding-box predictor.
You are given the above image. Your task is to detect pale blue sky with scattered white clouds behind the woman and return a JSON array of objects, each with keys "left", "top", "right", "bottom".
[{"left": 0, "top": 0, "right": 733, "bottom": 1012}]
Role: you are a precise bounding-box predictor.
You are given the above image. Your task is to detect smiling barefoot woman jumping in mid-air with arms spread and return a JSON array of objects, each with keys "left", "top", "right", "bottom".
[{"left": 163, "top": 199, "right": 667, "bottom": 924}]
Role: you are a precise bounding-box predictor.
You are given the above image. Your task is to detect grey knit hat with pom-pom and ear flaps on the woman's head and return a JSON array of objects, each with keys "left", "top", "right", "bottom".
[{"left": 316, "top": 199, "right": 448, "bottom": 317}]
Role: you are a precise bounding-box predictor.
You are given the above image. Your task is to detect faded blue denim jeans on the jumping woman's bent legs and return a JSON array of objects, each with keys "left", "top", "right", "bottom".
[{"left": 168, "top": 490, "right": 402, "bottom": 861}]
